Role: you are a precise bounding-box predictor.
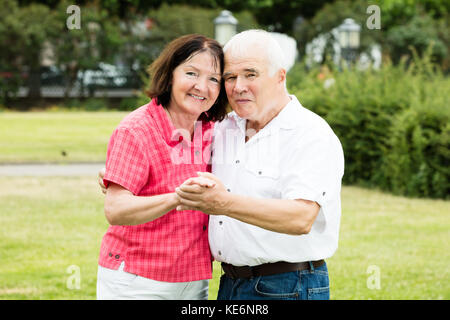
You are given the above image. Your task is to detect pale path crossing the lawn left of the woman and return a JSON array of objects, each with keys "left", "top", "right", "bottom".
[{"left": 0, "top": 162, "right": 105, "bottom": 177}]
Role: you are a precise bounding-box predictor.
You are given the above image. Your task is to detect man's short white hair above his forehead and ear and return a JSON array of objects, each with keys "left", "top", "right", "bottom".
[{"left": 223, "top": 29, "right": 287, "bottom": 76}]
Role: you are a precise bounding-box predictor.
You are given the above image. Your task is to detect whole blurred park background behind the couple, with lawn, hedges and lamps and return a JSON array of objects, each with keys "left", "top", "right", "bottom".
[{"left": 0, "top": 0, "right": 450, "bottom": 299}]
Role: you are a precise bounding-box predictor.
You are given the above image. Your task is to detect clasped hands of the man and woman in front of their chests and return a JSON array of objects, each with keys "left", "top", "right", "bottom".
[{"left": 175, "top": 172, "right": 228, "bottom": 215}]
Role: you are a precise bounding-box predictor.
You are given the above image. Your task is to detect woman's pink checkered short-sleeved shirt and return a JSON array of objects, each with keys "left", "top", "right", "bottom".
[{"left": 99, "top": 99, "right": 213, "bottom": 282}]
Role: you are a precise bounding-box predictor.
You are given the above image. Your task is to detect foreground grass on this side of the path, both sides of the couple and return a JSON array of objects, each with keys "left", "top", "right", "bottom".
[{"left": 0, "top": 176, "right": 450, "bottom": 299}]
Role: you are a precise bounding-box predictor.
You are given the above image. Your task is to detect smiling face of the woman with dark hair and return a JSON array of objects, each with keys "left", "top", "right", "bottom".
[{"left": 169, "top": 51, "right": 222, "bottom": 117}]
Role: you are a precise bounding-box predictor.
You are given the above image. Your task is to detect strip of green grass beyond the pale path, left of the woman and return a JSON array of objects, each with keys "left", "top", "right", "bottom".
[{"left": 0, "top": 112, "right": 127, "bottom": 163}]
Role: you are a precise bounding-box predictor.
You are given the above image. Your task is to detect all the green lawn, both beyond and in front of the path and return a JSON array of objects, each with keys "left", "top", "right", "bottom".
[{"left": 0, "top": 112, "right": 450, "bottom": 299}]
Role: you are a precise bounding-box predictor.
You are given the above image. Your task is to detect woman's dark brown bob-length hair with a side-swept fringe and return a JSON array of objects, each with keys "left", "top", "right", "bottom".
[{"left": 146, "top": 34, "right": 228, "bottom": 121}]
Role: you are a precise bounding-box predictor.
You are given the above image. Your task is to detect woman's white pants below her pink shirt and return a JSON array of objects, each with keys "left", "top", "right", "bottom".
[{"left": 97, "top": 262, "right": 209, "bottom": 300}]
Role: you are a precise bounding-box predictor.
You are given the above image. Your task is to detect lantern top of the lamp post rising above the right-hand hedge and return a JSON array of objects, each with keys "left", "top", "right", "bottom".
[{"left": 338, "top": 18, "right": 361, "bottom": 66}]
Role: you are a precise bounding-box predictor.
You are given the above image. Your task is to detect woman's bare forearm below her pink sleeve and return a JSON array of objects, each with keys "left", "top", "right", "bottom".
[{"left": 105, "top": 192, "right": 179, "bottom": 225}]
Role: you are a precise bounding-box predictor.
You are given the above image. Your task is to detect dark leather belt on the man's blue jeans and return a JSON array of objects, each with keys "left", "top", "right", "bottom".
[{"left": 222, "top": 260, "right": 325, "bottom": 279}]
